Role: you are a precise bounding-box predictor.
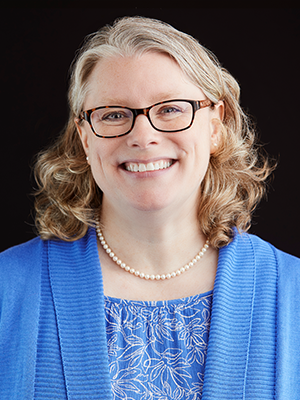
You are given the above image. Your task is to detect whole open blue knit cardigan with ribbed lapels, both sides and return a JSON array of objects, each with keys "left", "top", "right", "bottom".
[{"left": 0, "top": 229, "right": 300, "bottom": 400}]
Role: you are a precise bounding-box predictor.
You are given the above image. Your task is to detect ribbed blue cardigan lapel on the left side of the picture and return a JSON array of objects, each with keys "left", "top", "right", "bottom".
[{"left": 49, "top": 229, "right": 111, "bottom": 400}]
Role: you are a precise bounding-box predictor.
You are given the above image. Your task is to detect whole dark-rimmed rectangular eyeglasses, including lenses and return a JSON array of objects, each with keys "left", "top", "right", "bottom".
[{"left": 79, "top": 100, "right": 214, "bottom": 138}]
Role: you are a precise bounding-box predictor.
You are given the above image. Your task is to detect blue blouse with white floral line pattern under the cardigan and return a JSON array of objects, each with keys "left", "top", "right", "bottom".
[{"left": 105, "top": 291, "right": 212, "bottom": 400}]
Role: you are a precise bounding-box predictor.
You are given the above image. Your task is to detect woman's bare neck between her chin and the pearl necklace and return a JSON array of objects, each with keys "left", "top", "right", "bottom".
[{"left": 97, "top": 195, "right": 206, "bottom": 274}]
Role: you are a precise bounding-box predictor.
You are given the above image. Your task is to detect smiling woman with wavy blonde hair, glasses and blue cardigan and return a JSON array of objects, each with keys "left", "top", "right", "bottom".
[{"left": 0, "top": 17, "right": 300, "bottom": 400}]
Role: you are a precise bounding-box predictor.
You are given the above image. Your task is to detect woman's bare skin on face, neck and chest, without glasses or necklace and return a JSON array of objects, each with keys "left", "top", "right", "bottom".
[{"left": 77, "top": 53, "right": 223, "bottom": 300}]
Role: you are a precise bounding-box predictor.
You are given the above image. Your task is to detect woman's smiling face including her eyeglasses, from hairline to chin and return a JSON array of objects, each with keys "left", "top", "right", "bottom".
[{"left": 77, "top": 52, "right": 223, "bottom": 222}]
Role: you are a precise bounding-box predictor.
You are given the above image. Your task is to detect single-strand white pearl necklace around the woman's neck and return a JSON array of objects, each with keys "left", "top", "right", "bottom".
[{"left": 96, "top": 219, "right": 209, "bottom": 281}]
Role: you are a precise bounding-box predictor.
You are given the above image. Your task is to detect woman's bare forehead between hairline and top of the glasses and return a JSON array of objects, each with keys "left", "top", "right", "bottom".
[{"left": 85, "top": 52, "right": 204, "bottom": 108}]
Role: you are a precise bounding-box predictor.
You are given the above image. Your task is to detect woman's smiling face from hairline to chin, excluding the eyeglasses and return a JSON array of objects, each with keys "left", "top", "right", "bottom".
[{"left": 78, "top": 53, "right": 223, "bottom": 217}]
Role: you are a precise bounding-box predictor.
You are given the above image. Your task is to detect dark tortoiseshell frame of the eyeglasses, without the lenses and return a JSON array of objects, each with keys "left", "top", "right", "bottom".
[{"left": 79, "top": 99, "right": 214, "bottom": 139}]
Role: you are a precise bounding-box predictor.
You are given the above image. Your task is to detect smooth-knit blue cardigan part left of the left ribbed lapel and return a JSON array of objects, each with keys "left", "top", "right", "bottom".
[{"left": 0, "top": 239, "right": 43, "bottom": 400}]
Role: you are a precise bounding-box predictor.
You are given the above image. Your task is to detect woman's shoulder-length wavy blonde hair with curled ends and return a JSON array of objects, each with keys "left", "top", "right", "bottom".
[{"left": 34, "top": 17, "right": 273, "bottom": 248}]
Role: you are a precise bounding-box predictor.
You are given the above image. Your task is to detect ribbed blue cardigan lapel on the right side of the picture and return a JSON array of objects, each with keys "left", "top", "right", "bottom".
[{"left": 202, "top": 234, "right": 277, "bottom": 400}]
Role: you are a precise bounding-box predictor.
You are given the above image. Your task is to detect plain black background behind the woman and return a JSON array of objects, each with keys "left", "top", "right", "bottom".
[{"left": 0, "top": 7, "right": 300, "bottom": 256}]
